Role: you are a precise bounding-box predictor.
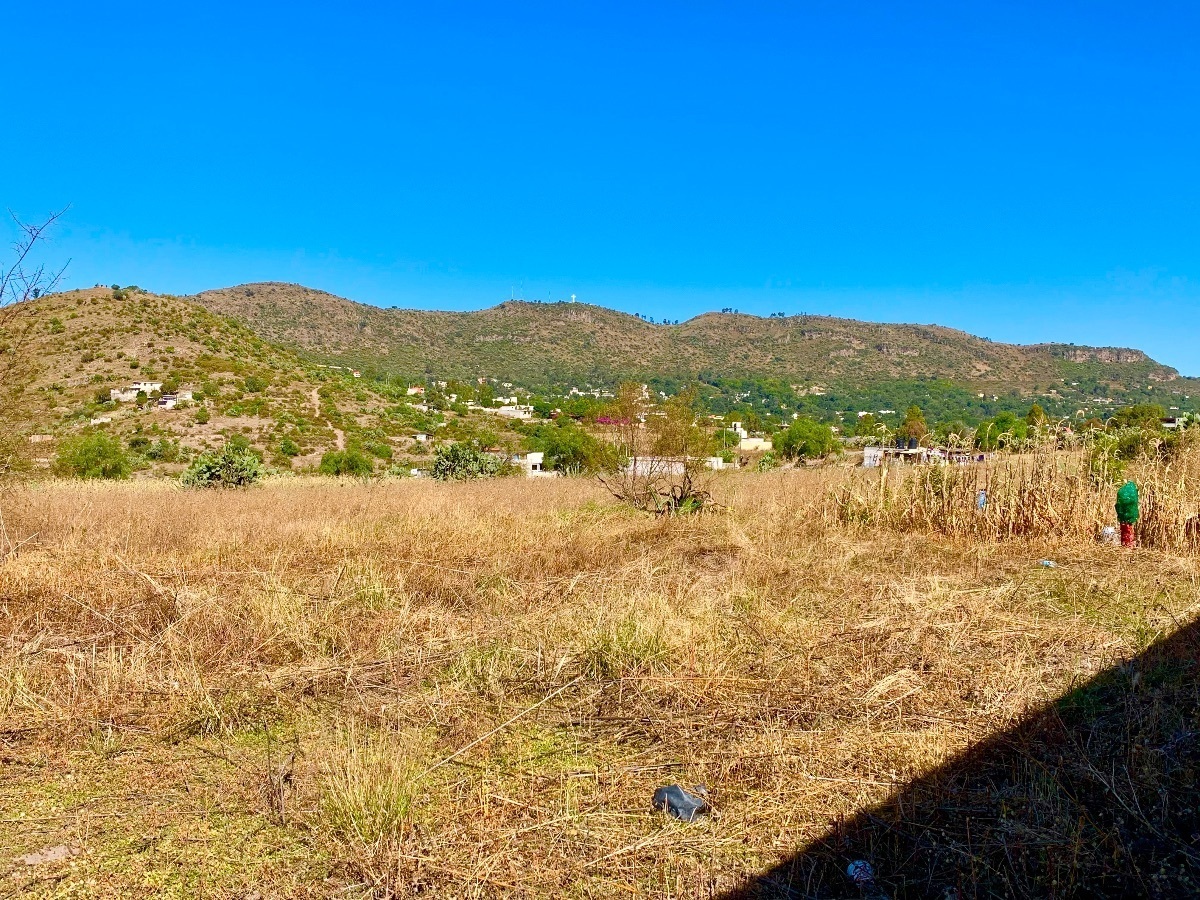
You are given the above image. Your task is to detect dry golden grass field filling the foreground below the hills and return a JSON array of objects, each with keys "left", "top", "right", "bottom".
[{"left": 0, "top": 469, "right": 1200, "bottom": 899}]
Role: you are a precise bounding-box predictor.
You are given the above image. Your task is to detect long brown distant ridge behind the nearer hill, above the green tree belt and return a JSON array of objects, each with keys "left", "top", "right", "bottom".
[{"left": 192, "top": 282, "right": 1200, "bottom": 400}]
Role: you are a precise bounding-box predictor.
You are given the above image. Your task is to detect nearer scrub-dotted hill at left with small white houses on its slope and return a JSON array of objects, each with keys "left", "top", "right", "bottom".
[{"left": 0, "top": 288, "right": 530, "bottom": 474}]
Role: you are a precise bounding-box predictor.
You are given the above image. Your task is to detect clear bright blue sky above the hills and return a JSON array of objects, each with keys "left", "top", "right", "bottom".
[{"left": 9, "top": 0, "right": 1200, "bottom": 374}]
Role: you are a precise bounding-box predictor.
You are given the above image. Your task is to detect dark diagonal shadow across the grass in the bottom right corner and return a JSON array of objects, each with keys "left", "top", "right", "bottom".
[{"left": 724, "top": 622, "right": 1200, "bottom": 900}]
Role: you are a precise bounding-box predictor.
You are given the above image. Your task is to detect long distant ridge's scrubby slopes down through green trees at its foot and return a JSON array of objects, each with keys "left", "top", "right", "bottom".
[{"left": 194, "top": 282, "right": 1200, "bottom": 427}]
